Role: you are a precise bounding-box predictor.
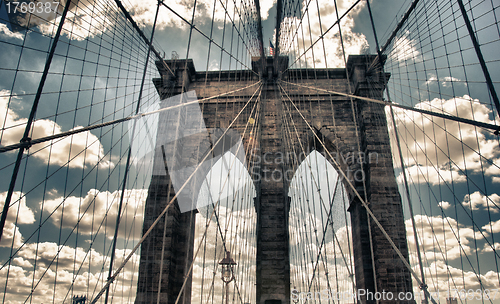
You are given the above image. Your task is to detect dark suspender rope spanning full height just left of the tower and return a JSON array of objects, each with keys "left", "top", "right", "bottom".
[{"left": 104, "top": 1, "right": 160, "bottom": 304}]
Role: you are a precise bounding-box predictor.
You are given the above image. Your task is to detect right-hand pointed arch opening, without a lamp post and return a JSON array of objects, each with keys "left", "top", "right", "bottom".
[{"left": 288, "top": 150, "right": 355, "bottom": 303}]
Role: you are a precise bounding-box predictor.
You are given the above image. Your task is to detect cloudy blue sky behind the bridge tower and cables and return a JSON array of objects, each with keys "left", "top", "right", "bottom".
[{"left": 0, "top": 0, "right": 500, "bottom": 303}]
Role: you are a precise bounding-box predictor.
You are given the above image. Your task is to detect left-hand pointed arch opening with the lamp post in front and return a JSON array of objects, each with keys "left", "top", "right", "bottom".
[{"left": 191, "top": 151, "right": 257, "bottom": 304}]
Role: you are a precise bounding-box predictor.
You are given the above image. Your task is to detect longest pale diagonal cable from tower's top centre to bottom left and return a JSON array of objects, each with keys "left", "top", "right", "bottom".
[{"left": 90, "top": 81, "right": 262, "bottom": 304}]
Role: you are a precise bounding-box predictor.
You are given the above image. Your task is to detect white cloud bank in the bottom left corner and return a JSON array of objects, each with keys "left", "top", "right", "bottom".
[{"left": 0, "top": 242, "right": 139, "bottom": 304}]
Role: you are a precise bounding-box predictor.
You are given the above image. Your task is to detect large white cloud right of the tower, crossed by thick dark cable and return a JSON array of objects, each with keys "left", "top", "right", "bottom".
[{"left": 389, "top": 95, "right": 500, "bottom": 185}]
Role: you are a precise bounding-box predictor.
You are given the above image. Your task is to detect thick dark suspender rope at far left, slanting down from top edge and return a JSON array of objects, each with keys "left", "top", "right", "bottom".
[{"left": 0, "top": 0, "right": 72, "bottom": 240}]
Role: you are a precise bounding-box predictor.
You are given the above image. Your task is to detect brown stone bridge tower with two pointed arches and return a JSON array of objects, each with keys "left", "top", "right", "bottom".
[{"left": 136, "top": 55, "right": 412, "bottom": 304}]
